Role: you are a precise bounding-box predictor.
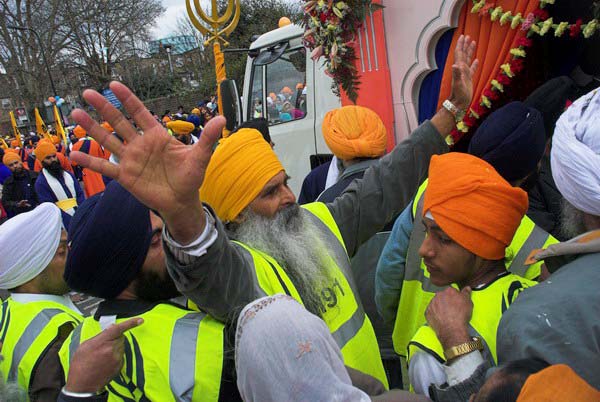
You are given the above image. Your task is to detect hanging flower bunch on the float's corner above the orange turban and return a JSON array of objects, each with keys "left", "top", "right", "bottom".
[{"left": 304, "top": 0, "right": 380, "bottom": 103}]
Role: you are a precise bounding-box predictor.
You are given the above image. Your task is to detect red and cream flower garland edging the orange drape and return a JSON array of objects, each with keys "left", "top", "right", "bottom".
[{"left": 446, "top": 0, "right": 600, "bottom": 145}]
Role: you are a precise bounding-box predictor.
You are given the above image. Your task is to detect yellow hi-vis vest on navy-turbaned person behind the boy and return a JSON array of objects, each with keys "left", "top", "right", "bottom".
[{"left": 392, "top": 180, "right": 558, "bottom": 356}]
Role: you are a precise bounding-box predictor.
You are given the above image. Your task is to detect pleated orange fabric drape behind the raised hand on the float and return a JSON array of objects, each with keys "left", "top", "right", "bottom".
[{"left": 438, "top": 0, "right": 540, "bottom": 108}]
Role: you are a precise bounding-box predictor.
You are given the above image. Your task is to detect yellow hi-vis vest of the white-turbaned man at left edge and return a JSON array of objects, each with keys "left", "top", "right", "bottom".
[{"left": 0, "top": 298, "right": 82, "bottom": 390}]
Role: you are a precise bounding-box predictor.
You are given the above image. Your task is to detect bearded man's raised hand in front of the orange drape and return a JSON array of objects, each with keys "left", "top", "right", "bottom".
[{"left": 450, "top": 35, "right": 479, "bottom": 111}]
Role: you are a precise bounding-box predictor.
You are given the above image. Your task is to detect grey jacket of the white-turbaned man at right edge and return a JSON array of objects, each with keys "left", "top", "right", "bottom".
[{"left": 498, "top": 253, "right": 600, "bottom": 388}]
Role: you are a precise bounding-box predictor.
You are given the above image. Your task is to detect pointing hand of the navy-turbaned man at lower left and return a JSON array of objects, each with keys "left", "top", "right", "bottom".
[{"left": 65, "top": 317, "right": 144, "bottom": 393}]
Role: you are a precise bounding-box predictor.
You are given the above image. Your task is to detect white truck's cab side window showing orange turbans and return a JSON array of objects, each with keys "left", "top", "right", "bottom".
[{"left": 265, "top": 47, "right": 306, "bottom": 125}]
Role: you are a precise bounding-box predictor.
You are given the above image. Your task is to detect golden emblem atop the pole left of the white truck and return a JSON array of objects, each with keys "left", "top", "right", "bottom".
[{"left": 185, "top": 0, "right": 241, "bottom": 46}]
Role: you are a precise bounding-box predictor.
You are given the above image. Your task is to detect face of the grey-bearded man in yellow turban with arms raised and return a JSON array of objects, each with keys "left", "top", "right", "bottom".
[{"left": 248, "top": 171, "right": 296, "bottom": 218}]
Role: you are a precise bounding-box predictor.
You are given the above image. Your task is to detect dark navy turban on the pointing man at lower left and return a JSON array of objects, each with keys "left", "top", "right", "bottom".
[{"left": 64, "top": 180, "right": 152, "bottom": 299}]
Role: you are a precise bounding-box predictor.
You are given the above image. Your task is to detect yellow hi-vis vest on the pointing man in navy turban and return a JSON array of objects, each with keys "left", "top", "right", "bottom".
[{"left": 59, "top": 303, "right": 224, "bottom": 402}]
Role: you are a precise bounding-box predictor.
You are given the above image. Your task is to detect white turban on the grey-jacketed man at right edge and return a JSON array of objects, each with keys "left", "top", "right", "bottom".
[{"left": 551, "top": 90, "right": 600, "bottom": 216}]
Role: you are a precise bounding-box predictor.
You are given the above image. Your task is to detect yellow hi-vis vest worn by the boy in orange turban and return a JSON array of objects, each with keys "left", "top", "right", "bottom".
[{"left": 408, "top": 272, "right": 536, "bottom": 366}]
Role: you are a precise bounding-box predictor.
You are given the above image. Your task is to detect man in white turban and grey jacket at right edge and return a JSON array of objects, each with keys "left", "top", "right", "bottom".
[{"left": 498, "top": 90, "right": 600, "bottom": 388}]
